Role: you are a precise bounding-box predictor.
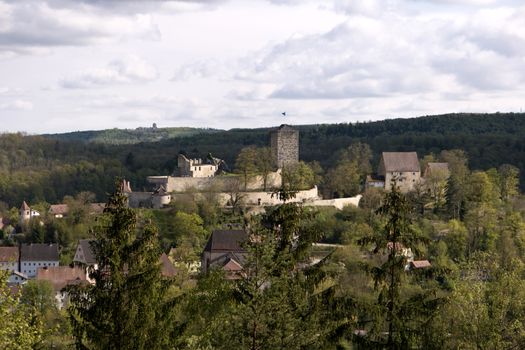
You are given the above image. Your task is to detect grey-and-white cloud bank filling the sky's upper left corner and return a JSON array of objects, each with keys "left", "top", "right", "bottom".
[{"left": 0, "top": 0, "right": 160, "bottom": 53}]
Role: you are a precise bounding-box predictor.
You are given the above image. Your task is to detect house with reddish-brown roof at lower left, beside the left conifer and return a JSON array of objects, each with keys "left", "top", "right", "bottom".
[{"left": 36, "top": 266, "right": 89, "bottom": 309}]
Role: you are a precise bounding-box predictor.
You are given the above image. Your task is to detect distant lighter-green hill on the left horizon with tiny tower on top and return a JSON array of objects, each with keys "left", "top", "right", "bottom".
[{"left": 42, "top": 127, "right": 217, "bottom": 145}]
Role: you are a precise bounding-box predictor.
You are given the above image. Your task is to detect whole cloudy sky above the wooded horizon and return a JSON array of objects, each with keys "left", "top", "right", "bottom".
[{"left": 0, "top": 0, "right": 525, "bottom": 134}]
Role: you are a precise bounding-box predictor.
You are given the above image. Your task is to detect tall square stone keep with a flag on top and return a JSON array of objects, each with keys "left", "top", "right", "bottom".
[{"left": 271, "top": 124, "right": 299, "bottom": 168}]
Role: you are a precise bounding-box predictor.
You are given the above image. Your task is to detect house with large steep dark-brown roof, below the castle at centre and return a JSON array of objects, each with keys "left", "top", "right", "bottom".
[{"left": 201, "top": 230, "right": 248, "bottom": 279}]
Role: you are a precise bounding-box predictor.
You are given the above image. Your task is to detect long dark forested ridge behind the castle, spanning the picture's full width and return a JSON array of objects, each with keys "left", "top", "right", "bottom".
[{"left": 0, "top": 114, "right": 525, "bottom": 207}]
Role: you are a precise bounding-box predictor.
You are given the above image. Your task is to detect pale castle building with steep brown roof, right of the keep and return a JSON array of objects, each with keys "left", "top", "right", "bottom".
[{"left": 378, "top": 152, "right": 421, "bottom": 193}]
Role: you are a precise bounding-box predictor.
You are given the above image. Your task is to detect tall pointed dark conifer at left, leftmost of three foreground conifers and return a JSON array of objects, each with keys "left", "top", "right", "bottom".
[{"left": 69, "top": 181, "right": 171, "bottom": 350}]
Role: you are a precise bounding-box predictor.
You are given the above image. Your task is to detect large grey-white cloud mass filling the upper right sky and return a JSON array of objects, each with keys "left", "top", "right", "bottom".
[{"left": 226, "top": 1, "right": 525, "bottom": 100}]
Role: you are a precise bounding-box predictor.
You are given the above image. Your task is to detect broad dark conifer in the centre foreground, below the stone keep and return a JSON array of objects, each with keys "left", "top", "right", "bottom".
[{"left": 226, "top": 193, "right": 348, "bottom": 350}]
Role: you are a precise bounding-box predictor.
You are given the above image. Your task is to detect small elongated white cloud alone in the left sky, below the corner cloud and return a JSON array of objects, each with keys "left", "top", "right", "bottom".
[{"left": 60, "top": 56, "right": 158, "bottom": 89}]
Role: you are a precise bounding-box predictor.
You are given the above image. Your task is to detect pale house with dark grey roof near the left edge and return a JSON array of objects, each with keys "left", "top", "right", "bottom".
[{"left": 19, "top": 243, "right": 60, "bottom": 278}]
